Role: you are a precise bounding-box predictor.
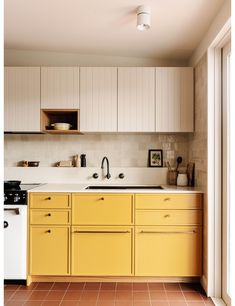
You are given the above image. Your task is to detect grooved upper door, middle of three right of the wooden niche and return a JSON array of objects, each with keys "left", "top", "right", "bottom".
[{"left": 118, "top": 67, "right": 155, "bottom": 132}]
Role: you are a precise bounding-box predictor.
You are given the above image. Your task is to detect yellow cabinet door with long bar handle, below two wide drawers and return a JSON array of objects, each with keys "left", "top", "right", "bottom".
[{"left": 135, "top": 226, "right": 202, "bottom": 277}]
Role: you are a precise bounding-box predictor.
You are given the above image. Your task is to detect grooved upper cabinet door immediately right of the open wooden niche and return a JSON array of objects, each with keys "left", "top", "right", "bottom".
[{"left": 80, "top": 67, "right": 117, "bottom": 132}]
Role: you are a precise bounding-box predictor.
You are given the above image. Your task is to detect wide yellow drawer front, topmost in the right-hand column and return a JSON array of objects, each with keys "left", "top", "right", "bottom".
[{"left": 135, "top": 194, "right": 202, "bottom": 209}]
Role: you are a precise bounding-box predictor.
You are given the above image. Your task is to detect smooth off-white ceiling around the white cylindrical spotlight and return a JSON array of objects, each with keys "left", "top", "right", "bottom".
[{"left": 4, "top": 0, "right": 224, "bottom": 59}]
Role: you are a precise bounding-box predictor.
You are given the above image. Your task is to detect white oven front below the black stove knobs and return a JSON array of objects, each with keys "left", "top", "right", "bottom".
[{"left": 4, "top": 205, "right": 27, "bottom": 280}]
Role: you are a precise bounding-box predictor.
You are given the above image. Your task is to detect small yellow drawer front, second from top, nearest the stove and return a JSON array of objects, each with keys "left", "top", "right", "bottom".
[{"left": 30, "top": 209, "right": 70, "bottom": 224}]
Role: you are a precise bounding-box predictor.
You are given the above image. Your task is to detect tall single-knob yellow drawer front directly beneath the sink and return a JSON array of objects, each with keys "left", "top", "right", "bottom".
[{"left": 72, "top": 194, "right": 133, "bottom": 225}]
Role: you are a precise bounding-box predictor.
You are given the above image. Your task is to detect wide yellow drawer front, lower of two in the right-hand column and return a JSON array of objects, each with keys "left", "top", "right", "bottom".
[{"left": 135, "top": 209, "right": 202, "bottom": 225}]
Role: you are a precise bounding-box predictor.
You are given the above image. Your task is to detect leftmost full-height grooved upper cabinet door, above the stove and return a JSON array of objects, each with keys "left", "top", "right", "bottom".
[{"left": 4, "top": 67, "right": 40, "bottom": 132}]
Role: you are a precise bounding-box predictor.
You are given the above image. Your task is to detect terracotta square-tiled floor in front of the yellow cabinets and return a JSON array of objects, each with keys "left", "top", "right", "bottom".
[{"left": 4, "top": 283, "right": 214, "bottom": 306}]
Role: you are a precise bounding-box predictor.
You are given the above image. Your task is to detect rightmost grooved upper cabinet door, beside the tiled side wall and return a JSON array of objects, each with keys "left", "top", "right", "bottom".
[{"left": 156, "top": 67, "right": 194, "bottom": 132}]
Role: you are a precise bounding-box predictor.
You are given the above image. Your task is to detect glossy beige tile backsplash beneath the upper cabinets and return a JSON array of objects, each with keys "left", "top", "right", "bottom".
[{"left": 4, "top": 134, "right": 189, "bottom": 167}]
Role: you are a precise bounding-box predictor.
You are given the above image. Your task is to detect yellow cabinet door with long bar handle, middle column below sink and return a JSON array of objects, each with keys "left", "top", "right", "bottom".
[{"left": 71, "top": 226, "right": 133, "bottom": 276}]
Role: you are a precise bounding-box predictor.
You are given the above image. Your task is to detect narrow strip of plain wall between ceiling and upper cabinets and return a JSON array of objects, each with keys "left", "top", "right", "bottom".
[{"left": 4, "top": 49, "right": 187, "bottom": 67}]
